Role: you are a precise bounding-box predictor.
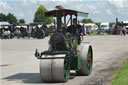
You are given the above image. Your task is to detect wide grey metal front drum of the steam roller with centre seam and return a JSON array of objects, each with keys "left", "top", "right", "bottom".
[{"left": 40, "top": 56, "right": 70, "bottom": 82}]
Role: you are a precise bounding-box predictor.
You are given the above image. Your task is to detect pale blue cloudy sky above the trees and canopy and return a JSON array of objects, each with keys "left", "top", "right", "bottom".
[{"left": 0, "top": 0, "right": 128, "bottom": 23}]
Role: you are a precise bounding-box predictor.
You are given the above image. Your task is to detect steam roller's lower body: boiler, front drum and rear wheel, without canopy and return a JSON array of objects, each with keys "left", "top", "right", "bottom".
[{"left": 35, "top": 33, "right": 93, "bottom": 82}]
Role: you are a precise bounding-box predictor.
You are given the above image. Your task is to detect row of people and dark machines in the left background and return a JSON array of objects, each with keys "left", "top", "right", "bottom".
[{"left": 0, "top": 26, "right": 48, "bottom": 39}]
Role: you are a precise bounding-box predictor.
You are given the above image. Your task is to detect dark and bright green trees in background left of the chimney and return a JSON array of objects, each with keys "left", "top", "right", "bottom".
[{"left": 0, "top": 5, "right": 54, "bottom": 25}]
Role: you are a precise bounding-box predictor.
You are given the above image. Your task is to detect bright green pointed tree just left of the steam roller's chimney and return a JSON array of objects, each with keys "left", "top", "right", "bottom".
[{"left": 33, "top": 5, "right": 54, "bottom": 23}]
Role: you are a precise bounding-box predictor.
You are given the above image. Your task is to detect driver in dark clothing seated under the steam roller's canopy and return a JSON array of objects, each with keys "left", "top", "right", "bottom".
[{"left": 66, "top": 18, "right": 85, "bottom": 49}]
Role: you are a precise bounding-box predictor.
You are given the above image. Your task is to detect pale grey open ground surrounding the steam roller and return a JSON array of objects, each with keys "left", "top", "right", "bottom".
[{"left": 0, "top": 36, "right": 128, "bottom": 85}]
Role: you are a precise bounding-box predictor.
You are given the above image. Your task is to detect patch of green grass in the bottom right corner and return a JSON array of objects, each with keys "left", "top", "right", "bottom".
[{"left": 112, "top": 61, "right": 128, "bottom": 85}]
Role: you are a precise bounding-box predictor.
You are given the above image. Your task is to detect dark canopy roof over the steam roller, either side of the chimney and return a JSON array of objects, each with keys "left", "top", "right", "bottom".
[{"left": 45, "top": 9, "right": 88, "bottom": 17}]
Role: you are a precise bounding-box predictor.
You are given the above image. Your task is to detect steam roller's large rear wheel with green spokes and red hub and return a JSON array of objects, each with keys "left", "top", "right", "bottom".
[{"left": 76, "top": 43, "right": 93, "bottom": 75}]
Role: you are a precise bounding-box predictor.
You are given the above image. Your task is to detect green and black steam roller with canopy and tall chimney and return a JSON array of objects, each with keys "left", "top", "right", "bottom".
[{"left": 35, "top": 6, "right": 93, "bottom": 82}]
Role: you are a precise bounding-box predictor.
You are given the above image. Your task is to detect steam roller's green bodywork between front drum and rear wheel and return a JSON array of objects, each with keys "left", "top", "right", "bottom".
[{"left": 41, "top": 36, "right": 82, "bottom": 70}]
